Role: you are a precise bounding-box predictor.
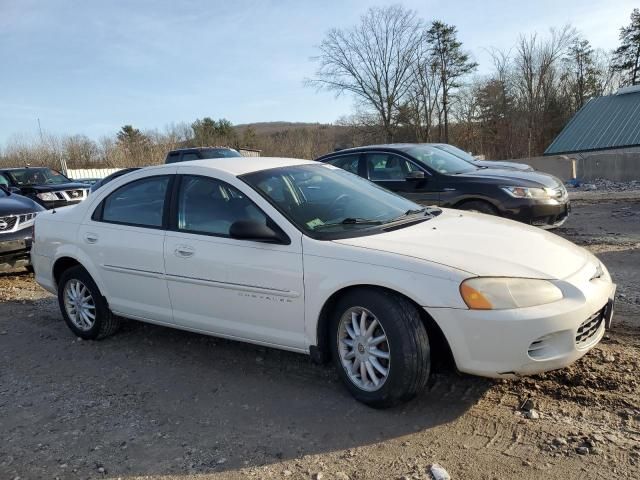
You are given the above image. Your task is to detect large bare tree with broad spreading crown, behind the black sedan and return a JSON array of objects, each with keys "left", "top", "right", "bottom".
[{"left": 308, "top": 5, "right": 422, "bottom": 141}]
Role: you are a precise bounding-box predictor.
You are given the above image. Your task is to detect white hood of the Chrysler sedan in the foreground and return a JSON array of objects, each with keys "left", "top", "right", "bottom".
[{"left": 334, "top": 209, "right": 593, "bottom": 279}]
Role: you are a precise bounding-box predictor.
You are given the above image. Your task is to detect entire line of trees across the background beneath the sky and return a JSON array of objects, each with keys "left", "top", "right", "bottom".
[{"left": 0, "top": 5, "right": 640, "bottom": 168}]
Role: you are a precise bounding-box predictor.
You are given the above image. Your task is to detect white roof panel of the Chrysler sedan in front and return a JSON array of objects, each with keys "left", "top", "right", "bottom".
[{"left": 157, "top": 157, "right": 317, "bottom": 176}]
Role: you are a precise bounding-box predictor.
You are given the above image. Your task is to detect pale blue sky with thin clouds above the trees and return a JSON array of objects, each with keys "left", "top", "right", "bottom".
[{"left": 0, "top": 0, "right": 637, "bottom": 145}]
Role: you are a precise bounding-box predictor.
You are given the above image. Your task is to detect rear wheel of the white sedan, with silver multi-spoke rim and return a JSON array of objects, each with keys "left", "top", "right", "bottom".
[{"left": 58, "top": 265, "right": 120, "bottom": 340}]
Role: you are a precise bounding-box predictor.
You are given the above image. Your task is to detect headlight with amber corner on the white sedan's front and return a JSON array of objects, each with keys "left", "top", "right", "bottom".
[{"left": 460, "top": 277, "right": 563, "bottom": 310}]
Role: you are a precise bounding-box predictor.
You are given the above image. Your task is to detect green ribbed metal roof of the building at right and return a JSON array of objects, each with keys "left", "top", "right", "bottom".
[{"left": 544, "top": 88, "right": 640, "bottom": 155}]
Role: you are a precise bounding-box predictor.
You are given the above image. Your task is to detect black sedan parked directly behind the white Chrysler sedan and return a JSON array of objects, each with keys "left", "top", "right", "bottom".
[{"left": 318, "top": 144, "right": 571, "bottom": 228}]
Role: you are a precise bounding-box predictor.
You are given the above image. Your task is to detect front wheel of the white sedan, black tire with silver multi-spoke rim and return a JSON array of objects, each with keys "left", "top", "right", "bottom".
[{"left": 329, "top": 288, "right": 431, "bottom": 408}]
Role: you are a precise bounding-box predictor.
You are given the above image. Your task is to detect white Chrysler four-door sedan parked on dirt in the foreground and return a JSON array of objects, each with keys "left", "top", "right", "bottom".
[{"left": 32, "top": 158, "right": 615, "bottom": 407}]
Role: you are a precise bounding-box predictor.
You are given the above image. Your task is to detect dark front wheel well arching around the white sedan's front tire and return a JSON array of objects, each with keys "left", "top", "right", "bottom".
[{"left": 311, "top": 285, "right": 455, "bottom": 372}]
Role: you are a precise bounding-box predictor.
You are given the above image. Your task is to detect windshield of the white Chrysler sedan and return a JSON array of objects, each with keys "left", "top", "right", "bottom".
[{"left": 241, "top": 164, "right": 432, "bottom": 239}]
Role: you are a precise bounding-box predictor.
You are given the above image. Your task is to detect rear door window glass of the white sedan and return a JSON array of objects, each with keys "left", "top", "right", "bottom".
[{"left": 94, "top": 175, "right": 169, "bottom": 228}]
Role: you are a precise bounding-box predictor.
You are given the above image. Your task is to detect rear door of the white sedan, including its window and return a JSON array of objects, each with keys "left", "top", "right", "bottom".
[{"left": 78, "top": 175, "right": 173, "bottom": 322}]
